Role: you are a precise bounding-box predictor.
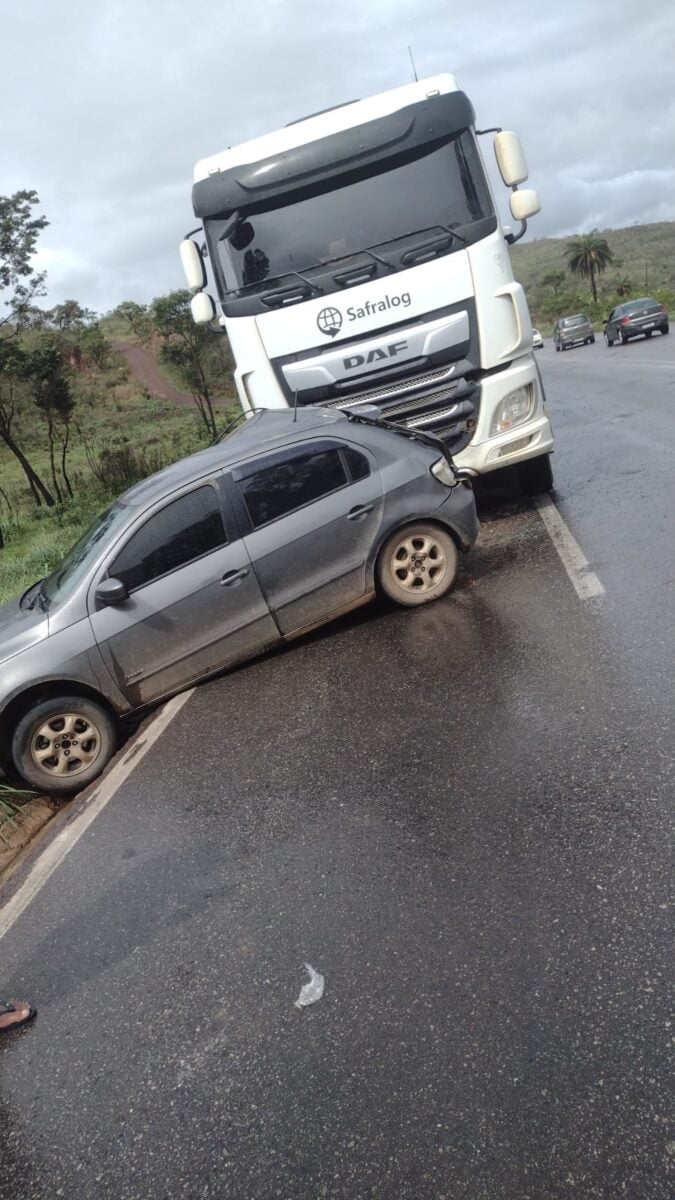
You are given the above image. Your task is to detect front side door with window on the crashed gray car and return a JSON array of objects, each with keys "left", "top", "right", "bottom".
[{"left": 89, "top": 480, "right": 279, "bottom": 707}]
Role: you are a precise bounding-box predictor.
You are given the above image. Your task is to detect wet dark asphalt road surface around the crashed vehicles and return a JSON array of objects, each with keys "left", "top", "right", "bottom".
[{"left": 0, "top": 337, "right": 675, "bottom": 1200}]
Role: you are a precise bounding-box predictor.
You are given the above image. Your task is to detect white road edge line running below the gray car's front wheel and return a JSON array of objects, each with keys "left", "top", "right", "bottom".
[{"left": 0, "top": 688, "right": 195, "bottom": 941}]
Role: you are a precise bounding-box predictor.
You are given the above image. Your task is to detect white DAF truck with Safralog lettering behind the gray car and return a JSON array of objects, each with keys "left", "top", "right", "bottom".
[{"left": 180, "top": 74, "right": 552, "bottom": 492}]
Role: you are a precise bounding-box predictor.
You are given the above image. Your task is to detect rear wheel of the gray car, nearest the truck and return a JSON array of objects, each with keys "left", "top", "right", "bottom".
[{"left": 376, "top": 521, "right": 459, "bottom": 608}]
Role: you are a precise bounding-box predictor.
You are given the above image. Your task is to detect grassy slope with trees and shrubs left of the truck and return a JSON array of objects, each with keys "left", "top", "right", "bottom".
[{"left": 0, "top": 192, "right": 240, "bottom": 602}]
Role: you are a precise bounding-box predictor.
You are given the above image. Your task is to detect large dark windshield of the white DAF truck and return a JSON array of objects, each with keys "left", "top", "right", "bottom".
[{"left": 212, "top": 131, "right": 494, "bottom": 293}]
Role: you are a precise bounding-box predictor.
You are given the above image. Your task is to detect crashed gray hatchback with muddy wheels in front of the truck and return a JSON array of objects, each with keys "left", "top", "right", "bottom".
[{"left": 0, "top": 408, "right": 478, "bottom": 792}]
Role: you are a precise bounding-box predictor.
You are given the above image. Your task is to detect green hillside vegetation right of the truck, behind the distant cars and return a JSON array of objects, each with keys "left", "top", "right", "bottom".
[{"left": 510, "top": 221, "right": 675, "bottom": 334}]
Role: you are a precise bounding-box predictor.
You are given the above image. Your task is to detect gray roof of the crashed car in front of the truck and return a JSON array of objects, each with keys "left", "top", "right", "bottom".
[{"left": 120, "top": 407, "right": 347, "bottom": 508}]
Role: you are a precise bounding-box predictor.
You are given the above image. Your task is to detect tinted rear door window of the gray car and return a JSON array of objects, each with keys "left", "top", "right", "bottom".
[{"left": 238, "top": 448, "right": 350, "bottom": 529}]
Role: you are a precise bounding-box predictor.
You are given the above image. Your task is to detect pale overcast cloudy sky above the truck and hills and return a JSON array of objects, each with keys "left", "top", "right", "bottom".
[{"left": 0, "top": 0, "right": 675, "bottom": 312}]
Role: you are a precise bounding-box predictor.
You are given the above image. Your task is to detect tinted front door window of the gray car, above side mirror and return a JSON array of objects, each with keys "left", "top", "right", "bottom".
[{"left": 108, "top": 485, "right": 227, "bottom": 592}]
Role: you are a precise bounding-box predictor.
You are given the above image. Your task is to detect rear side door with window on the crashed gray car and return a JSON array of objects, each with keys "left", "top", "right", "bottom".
[{"left": 233, "top": 440, "right": 384, "bottom": 635}]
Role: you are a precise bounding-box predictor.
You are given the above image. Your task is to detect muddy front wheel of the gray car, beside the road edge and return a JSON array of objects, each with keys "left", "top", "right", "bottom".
[{"left": 12, "top": 695, "right": 118, "bottom": 796}]
